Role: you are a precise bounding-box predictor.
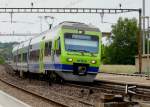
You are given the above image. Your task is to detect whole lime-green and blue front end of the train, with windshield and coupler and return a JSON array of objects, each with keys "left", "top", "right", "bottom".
[{"left": 56, "top": 24, "right": 101, "bottom": 82}]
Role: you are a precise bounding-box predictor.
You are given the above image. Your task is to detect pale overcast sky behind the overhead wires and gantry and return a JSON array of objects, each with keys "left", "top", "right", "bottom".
[{"left": 0, "top": 0, "right": 150, "bottom": 42}]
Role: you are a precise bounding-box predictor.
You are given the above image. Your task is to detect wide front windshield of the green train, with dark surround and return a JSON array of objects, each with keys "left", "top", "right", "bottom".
[{"left": 65, "top": 33, "right": 99, "bottom": 53}]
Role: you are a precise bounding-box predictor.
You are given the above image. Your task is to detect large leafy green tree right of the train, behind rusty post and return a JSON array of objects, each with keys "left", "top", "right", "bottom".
[{"left": 103, "top": 18, "right": 138, "bottom": 64}]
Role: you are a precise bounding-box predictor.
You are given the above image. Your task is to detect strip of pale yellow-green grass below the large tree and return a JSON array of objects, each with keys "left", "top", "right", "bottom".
[{"left": 100, "top": 65, "right": 136, "bottom": 74}]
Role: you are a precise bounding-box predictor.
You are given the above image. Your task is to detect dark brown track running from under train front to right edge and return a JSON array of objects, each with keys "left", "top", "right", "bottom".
[{"left": 67, "top": 80, "right": 150, "bottom": 101}]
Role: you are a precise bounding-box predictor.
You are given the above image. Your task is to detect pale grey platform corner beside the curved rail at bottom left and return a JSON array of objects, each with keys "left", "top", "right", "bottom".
[{"left": 0, "top": 90, "right": 31, "bottom": 107}]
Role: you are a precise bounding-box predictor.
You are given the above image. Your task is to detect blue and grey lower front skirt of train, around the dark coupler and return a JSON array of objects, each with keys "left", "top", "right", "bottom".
[{"left": 55, "top": 64, "right": 99, "bottom": 82}]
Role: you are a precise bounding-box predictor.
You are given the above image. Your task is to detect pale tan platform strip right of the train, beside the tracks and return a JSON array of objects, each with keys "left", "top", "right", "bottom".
[{"left": 96, "top": 73, "right": 150, "bottom": 87}]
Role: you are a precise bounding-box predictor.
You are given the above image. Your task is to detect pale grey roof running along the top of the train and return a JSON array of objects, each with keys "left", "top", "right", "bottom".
[{"left": 13, "top": 21, "right": 100, "bottom": 52}]
